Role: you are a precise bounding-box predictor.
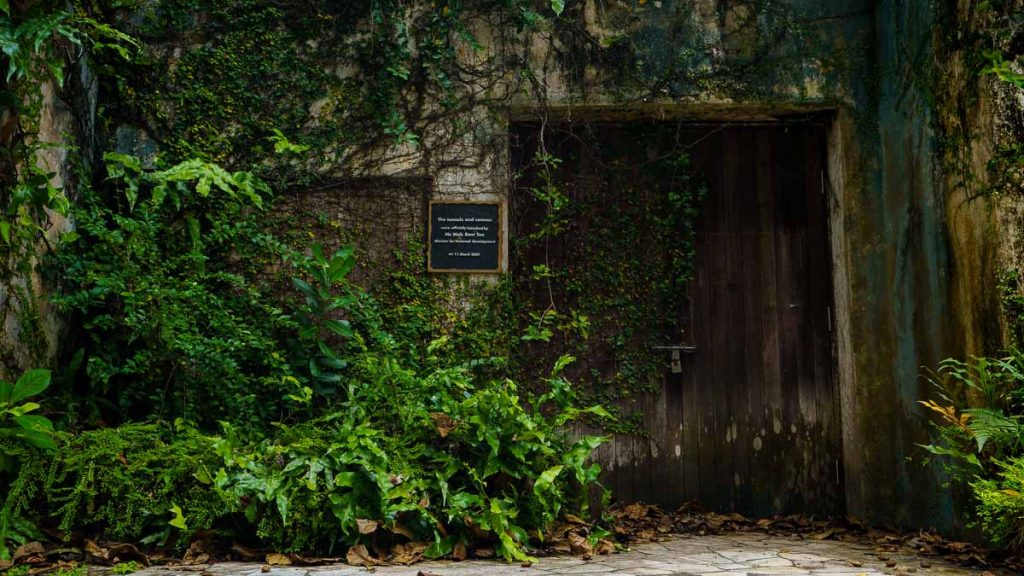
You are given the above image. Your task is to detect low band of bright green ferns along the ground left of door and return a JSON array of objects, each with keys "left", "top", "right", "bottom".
[{"left": 36, "top": 289, "right": 607, "bottom": 560}]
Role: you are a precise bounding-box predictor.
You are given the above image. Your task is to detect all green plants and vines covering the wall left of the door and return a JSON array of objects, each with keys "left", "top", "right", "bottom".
[{"left": 0, "top": 0, "right": 880, "bottom": 559}]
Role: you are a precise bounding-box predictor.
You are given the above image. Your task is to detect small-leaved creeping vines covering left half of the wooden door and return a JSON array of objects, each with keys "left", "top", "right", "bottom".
[{"left": 513, "top": 127, "right": 705, "bottom": 431}]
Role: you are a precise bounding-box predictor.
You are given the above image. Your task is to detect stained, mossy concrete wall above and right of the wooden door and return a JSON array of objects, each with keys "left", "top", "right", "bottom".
[{"left": 485, "top": 0, "right": 1005, "bottom": 530}]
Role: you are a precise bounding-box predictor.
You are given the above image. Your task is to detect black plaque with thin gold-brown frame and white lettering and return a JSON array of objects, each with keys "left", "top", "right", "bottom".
[{"left": 428, "top": 202, "right": 501, "bottom": 272}]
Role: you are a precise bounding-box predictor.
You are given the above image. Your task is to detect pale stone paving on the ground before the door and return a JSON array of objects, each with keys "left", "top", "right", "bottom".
[{"left": 135, "top": 532, "right": 1009, "bottom": 576}]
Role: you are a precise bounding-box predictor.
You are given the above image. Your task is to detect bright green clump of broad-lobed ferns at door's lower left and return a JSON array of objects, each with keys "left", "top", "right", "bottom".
[{"left": 209, "top": 349, "right": 601, "bottom": 560}]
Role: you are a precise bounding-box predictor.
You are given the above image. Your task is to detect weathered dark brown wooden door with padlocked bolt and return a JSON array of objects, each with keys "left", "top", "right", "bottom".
[{"left": 509, "top": 123, "right": 844, "bottom": 516}]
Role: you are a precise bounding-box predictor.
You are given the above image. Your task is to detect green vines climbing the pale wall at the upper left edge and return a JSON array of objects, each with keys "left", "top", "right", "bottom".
[{"left": 0, "top": 1, "right": 135, "bottom": 374}]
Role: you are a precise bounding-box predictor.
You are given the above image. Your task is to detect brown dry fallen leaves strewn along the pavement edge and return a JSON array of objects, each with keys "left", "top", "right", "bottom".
[{"left": 8, "top": 502, "right": 1024, "bottom": 575}]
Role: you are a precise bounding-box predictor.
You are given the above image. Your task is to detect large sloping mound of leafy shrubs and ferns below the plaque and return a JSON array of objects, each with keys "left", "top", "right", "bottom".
[{"left": 0, "top": 155, "right": 607, "bottom": 560}]
